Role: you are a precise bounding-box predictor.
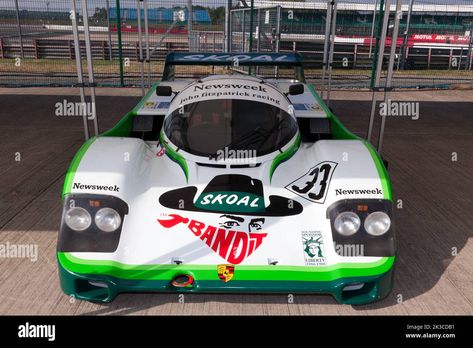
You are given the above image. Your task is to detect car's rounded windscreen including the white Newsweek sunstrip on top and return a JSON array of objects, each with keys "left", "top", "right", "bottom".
[{"left": 164, "top": 76, "right": 297, "bottom": 157}]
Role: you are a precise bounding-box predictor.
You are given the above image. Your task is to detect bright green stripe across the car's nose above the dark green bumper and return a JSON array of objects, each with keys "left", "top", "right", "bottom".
[{"left": 57, "top": 252, "right": 395, "bottom": 281}]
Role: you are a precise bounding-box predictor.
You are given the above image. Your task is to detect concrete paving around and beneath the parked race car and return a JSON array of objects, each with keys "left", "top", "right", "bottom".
[{"left": 0, "top": 89, "right": 473, "bottom": 315}]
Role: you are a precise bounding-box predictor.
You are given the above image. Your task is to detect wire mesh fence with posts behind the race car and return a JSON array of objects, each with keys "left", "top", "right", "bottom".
[{"left": 0, "top": 0, "right": 473, "bottom": 88}]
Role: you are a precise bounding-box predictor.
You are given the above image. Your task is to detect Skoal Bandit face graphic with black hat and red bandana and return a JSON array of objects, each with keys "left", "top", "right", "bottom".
[{"left": 158, "top": 175, "right": 302, "bottom": 265}]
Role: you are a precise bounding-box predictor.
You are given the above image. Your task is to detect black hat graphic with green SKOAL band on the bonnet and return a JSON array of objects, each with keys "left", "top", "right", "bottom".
[{"left": 159, "top": 174, "right": 303, "bottom": 216}]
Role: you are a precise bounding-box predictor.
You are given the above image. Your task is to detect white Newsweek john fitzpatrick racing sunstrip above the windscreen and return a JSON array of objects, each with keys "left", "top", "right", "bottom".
[{"left": 169, "top": 78, "right": 290, "bottom": 112}]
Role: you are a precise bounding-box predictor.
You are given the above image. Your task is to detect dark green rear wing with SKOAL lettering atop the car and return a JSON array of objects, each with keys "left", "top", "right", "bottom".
[{"left": 163, "top": 52, "right": 305, "bottom": 82}]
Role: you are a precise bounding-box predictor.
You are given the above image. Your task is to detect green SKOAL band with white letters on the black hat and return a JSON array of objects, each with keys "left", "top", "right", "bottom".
[{"left": 195, "top": 191, "right": 264, "bottom": 212}]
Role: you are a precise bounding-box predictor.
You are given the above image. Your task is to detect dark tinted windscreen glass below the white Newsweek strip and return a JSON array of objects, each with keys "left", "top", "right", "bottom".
[{"left": 164, "top": 99, "right": 297, "bottom": 157}]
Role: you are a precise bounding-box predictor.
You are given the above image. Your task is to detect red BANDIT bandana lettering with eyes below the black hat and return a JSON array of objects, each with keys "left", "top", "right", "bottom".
[{"left": 158, "top": 214, "right": 267, "bottom": 265}]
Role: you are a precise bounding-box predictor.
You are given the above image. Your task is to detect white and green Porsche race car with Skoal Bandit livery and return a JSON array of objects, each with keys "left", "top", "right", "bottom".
[{"left": 57, "top": 53, "right": 395, "bottom": 304}]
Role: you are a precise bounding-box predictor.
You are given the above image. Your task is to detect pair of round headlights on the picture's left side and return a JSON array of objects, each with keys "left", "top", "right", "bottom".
[{"left": 64, "top": 207, "right": 122, "bottom": 232}]
